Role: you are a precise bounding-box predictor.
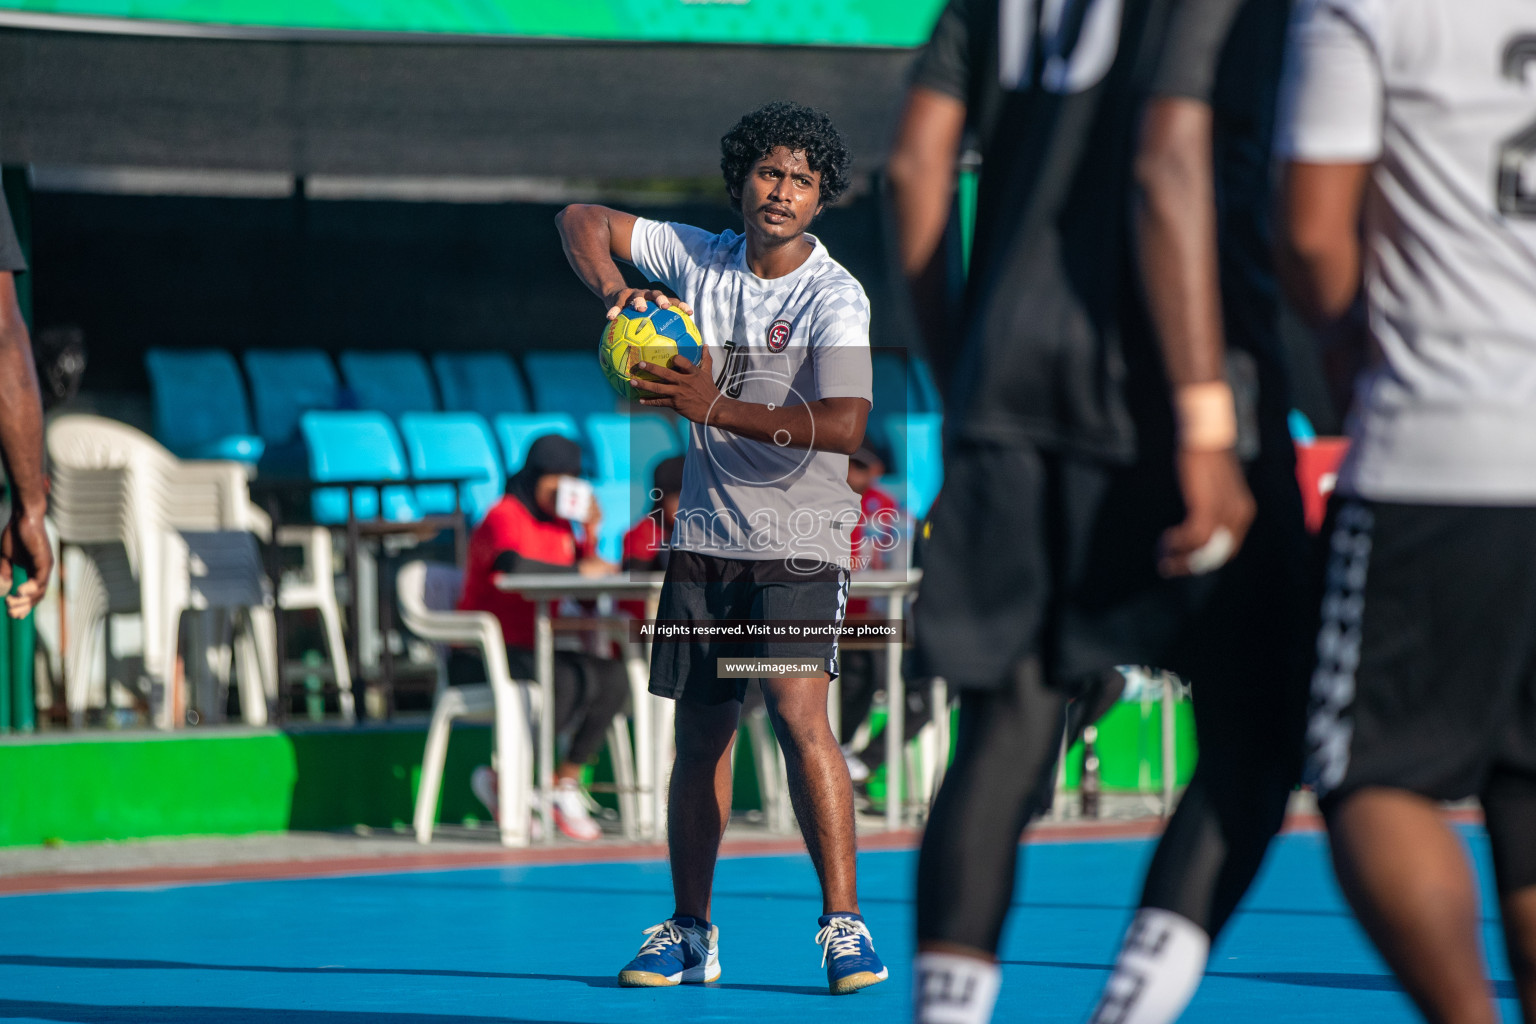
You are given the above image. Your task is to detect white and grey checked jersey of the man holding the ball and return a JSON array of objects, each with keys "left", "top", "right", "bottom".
[{"left": 630, "top": 218, "right": 872, "bottom": 567}]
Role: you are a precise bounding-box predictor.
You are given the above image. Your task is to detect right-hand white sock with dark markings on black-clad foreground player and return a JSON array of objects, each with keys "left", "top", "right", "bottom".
[{"left": 1089, "top": 907, "right": 1210, "bottom": 1024}]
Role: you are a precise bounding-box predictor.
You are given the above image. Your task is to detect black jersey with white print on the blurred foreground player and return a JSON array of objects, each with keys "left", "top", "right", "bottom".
[{"left": 914, "top": 0, "right": 1289, "bottom": 461}]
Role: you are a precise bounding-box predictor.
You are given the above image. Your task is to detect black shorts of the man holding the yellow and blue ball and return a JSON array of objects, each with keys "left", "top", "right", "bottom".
[{"left": 650, "top": 551, "right": 848, "bottom": 705}]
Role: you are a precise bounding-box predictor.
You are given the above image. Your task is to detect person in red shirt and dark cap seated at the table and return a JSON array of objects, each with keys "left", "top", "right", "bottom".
[{"left": 449, "top": 434, "right": 630, "bottom": 840}]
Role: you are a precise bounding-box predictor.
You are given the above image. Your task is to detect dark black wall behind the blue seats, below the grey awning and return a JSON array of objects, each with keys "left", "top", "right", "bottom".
[{"left": 31, "top": 192, "right": 906, "bottom": 391}]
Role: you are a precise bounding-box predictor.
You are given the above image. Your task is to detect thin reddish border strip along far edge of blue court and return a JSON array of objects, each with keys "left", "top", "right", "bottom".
[{"left": 0, "top": 811, "right": 1482, "bottom": 897}]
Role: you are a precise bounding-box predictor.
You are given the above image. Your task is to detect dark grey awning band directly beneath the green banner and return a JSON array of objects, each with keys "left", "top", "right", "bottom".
[{"left": 0, "top": 28, "right": 912, "bottom": 180}]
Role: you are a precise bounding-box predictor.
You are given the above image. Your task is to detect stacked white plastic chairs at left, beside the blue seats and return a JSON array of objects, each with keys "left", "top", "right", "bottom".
[{"left": 48, "top": 416, "right": 350, "bottom": 728}]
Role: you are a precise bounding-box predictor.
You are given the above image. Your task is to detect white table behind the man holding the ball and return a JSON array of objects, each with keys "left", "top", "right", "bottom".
[{"left": 492, "top": 570, "right": 921, "bottom": 843}]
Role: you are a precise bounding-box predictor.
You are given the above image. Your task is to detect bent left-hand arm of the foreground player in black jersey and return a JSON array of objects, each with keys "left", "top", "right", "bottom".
[{"left": 886, "top": 86, "right": 966, "bottom": 363}]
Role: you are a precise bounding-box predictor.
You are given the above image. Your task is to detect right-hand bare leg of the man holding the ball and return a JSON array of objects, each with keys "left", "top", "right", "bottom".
[{"left": 763, "top": 676, "right": 859, "bottom": 913}]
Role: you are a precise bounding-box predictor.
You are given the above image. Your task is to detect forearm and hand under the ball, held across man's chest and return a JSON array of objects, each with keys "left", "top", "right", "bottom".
[{"left": 634, "top": 348, "right": 869, "bottom": 454}]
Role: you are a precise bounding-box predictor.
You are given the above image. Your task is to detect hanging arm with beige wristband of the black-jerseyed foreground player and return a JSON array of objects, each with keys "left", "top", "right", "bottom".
[{"left": 1135, "top": 97, "right": 1255, "bottom": 576}]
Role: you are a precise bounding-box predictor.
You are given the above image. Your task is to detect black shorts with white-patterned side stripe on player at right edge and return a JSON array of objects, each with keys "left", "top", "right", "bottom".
[{"left": 1307, "top": 497, "right": 1536, "bottom": 808}]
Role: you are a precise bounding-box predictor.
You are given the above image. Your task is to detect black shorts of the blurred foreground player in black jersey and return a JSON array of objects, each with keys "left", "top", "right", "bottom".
[{"left": 914, "top": 438, "right": 1316, "bottom": 706}]
